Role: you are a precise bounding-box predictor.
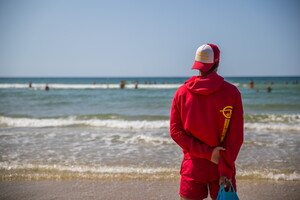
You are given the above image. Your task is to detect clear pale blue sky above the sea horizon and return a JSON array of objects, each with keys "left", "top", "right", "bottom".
[{"left": 0, "top": 0, "right": 300, "bottom": 77}]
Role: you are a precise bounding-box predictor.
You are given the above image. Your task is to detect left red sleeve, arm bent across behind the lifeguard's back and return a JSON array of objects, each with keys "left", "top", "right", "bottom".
[{"left": 170, "top": 92, "right": 213, "bottom": 160}]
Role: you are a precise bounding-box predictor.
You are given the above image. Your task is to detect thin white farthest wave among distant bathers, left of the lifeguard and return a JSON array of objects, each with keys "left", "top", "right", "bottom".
[{"left": 0, "top": 83, "right": 182, "bottom": 90}]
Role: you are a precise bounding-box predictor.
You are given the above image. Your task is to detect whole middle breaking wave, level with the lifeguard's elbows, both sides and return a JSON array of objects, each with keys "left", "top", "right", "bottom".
[{"left": 0, "top": 114, "right": 300, "bottom": 132}]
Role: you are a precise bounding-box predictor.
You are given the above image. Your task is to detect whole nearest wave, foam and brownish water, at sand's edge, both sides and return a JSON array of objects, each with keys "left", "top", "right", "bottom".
[{"left": 0, "top": 162, "right": 300, "bottom": 181}]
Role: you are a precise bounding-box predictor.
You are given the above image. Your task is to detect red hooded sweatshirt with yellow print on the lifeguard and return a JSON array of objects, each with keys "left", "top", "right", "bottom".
[{"left": 170, "top": 73, "right": 244, "bottom": 178}]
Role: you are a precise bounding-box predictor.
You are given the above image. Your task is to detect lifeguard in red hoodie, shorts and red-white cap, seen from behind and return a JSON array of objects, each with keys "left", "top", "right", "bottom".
[{"left": 170, "top": 44, "right": 244, "bottom": 199}]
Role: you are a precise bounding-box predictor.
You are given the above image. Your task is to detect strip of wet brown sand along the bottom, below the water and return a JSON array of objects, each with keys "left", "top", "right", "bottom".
[{"left": 0, "top": 180, "right": 300, "bottom": 200}]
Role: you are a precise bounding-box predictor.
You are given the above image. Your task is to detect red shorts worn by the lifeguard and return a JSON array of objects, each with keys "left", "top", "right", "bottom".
[{"left": 179, "top": 157, "right": 220, "bottom": 199}]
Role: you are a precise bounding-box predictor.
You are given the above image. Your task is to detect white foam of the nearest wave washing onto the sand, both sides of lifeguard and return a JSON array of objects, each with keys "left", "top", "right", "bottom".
[{"left": 0, "top": 162, "right": 300, "bottom": 181}]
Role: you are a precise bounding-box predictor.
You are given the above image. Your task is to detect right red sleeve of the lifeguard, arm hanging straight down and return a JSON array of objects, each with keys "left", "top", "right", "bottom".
[{"left": 219, "top": 92, "right": 244, "bottom": 178}]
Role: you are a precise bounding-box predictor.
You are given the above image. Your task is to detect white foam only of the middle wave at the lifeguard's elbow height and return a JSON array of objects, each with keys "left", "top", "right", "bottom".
[{"left": 0, "top": 116, "right": 300, "bottom": 132}]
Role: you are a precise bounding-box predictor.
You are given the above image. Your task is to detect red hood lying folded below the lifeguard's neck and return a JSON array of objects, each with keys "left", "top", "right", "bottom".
[{"left": 184, "top": 73, "right": 224, "bottom": 95}]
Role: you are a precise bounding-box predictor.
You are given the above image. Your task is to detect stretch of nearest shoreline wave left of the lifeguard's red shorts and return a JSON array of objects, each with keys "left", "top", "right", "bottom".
[{"left": 0, "top": 162, "right": 178, "bottom": 180}]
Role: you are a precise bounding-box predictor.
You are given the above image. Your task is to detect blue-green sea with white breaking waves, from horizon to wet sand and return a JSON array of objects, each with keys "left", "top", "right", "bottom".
[{"left": 0, "top": 77, "right": 300, "bottom": 181}]
